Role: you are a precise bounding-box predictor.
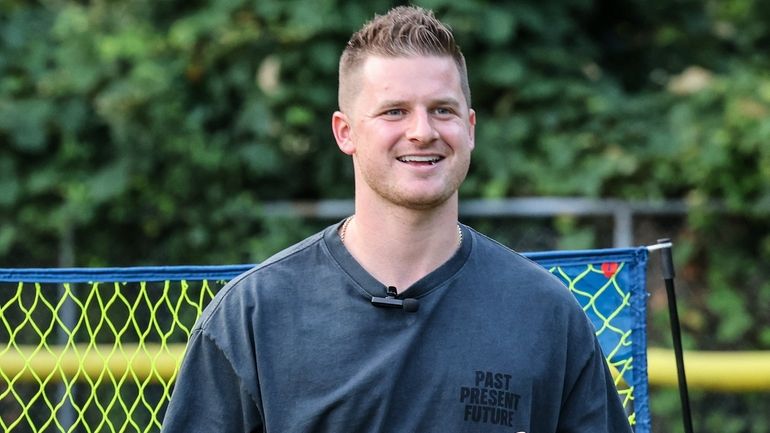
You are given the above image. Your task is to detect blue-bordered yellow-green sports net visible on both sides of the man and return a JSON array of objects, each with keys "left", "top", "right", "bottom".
[{"left": 0, "top": 249, "right": 650, "bottom": 433}]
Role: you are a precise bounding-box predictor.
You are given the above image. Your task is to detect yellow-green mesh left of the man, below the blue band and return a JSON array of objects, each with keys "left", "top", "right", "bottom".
[{"left": 0, "top": 280, "right": 224, "bottom": 432}]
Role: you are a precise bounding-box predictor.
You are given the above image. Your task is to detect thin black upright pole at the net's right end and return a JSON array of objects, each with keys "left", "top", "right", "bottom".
[{"left": 658, "top": 239, "right": 693, "bottom": 433}]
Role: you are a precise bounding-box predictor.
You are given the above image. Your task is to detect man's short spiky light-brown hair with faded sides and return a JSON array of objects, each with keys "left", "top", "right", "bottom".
[{"left": 337, "top": 6, "right": 471, "bottom": 112}]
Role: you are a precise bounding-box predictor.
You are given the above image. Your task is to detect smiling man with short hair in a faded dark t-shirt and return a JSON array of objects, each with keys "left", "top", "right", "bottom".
[{"left": 163, "top": 7, "right": 631, "bottom": 433}]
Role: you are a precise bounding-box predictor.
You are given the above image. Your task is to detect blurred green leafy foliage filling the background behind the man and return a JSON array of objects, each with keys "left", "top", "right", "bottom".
[{"left": 0, "top": 0, "right": 770, "bottom": 426}]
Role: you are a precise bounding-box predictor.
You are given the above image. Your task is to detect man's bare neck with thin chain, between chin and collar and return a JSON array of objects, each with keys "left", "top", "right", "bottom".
[{"left": 343, "top": 199, "right": 461, "bottom": 292}]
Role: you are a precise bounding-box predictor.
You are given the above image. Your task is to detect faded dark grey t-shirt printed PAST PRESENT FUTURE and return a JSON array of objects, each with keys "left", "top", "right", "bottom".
[{"left": 163, "top": 224, "right": 631, "bottom": 433}]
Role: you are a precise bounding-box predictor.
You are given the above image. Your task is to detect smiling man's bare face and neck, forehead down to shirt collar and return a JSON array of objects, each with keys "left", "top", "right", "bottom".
[{"left": 332, "top": 50, "right": 476, "bottom": 290}]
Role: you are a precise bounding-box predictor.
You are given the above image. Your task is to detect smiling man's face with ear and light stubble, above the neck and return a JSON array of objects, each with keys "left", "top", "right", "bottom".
[{"left": 332, "top": 56, "right": 476, "bottom": 209}]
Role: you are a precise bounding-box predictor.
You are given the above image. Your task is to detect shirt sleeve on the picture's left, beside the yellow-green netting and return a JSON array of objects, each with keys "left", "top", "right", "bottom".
[{"left": 161, "top": 330, "right": 263, "bottom": 433}]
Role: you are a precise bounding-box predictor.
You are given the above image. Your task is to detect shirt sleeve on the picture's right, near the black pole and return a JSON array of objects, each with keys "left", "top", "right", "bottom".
[{"left": 557, "top": 339, "right": 632, "bottom": 433}]
